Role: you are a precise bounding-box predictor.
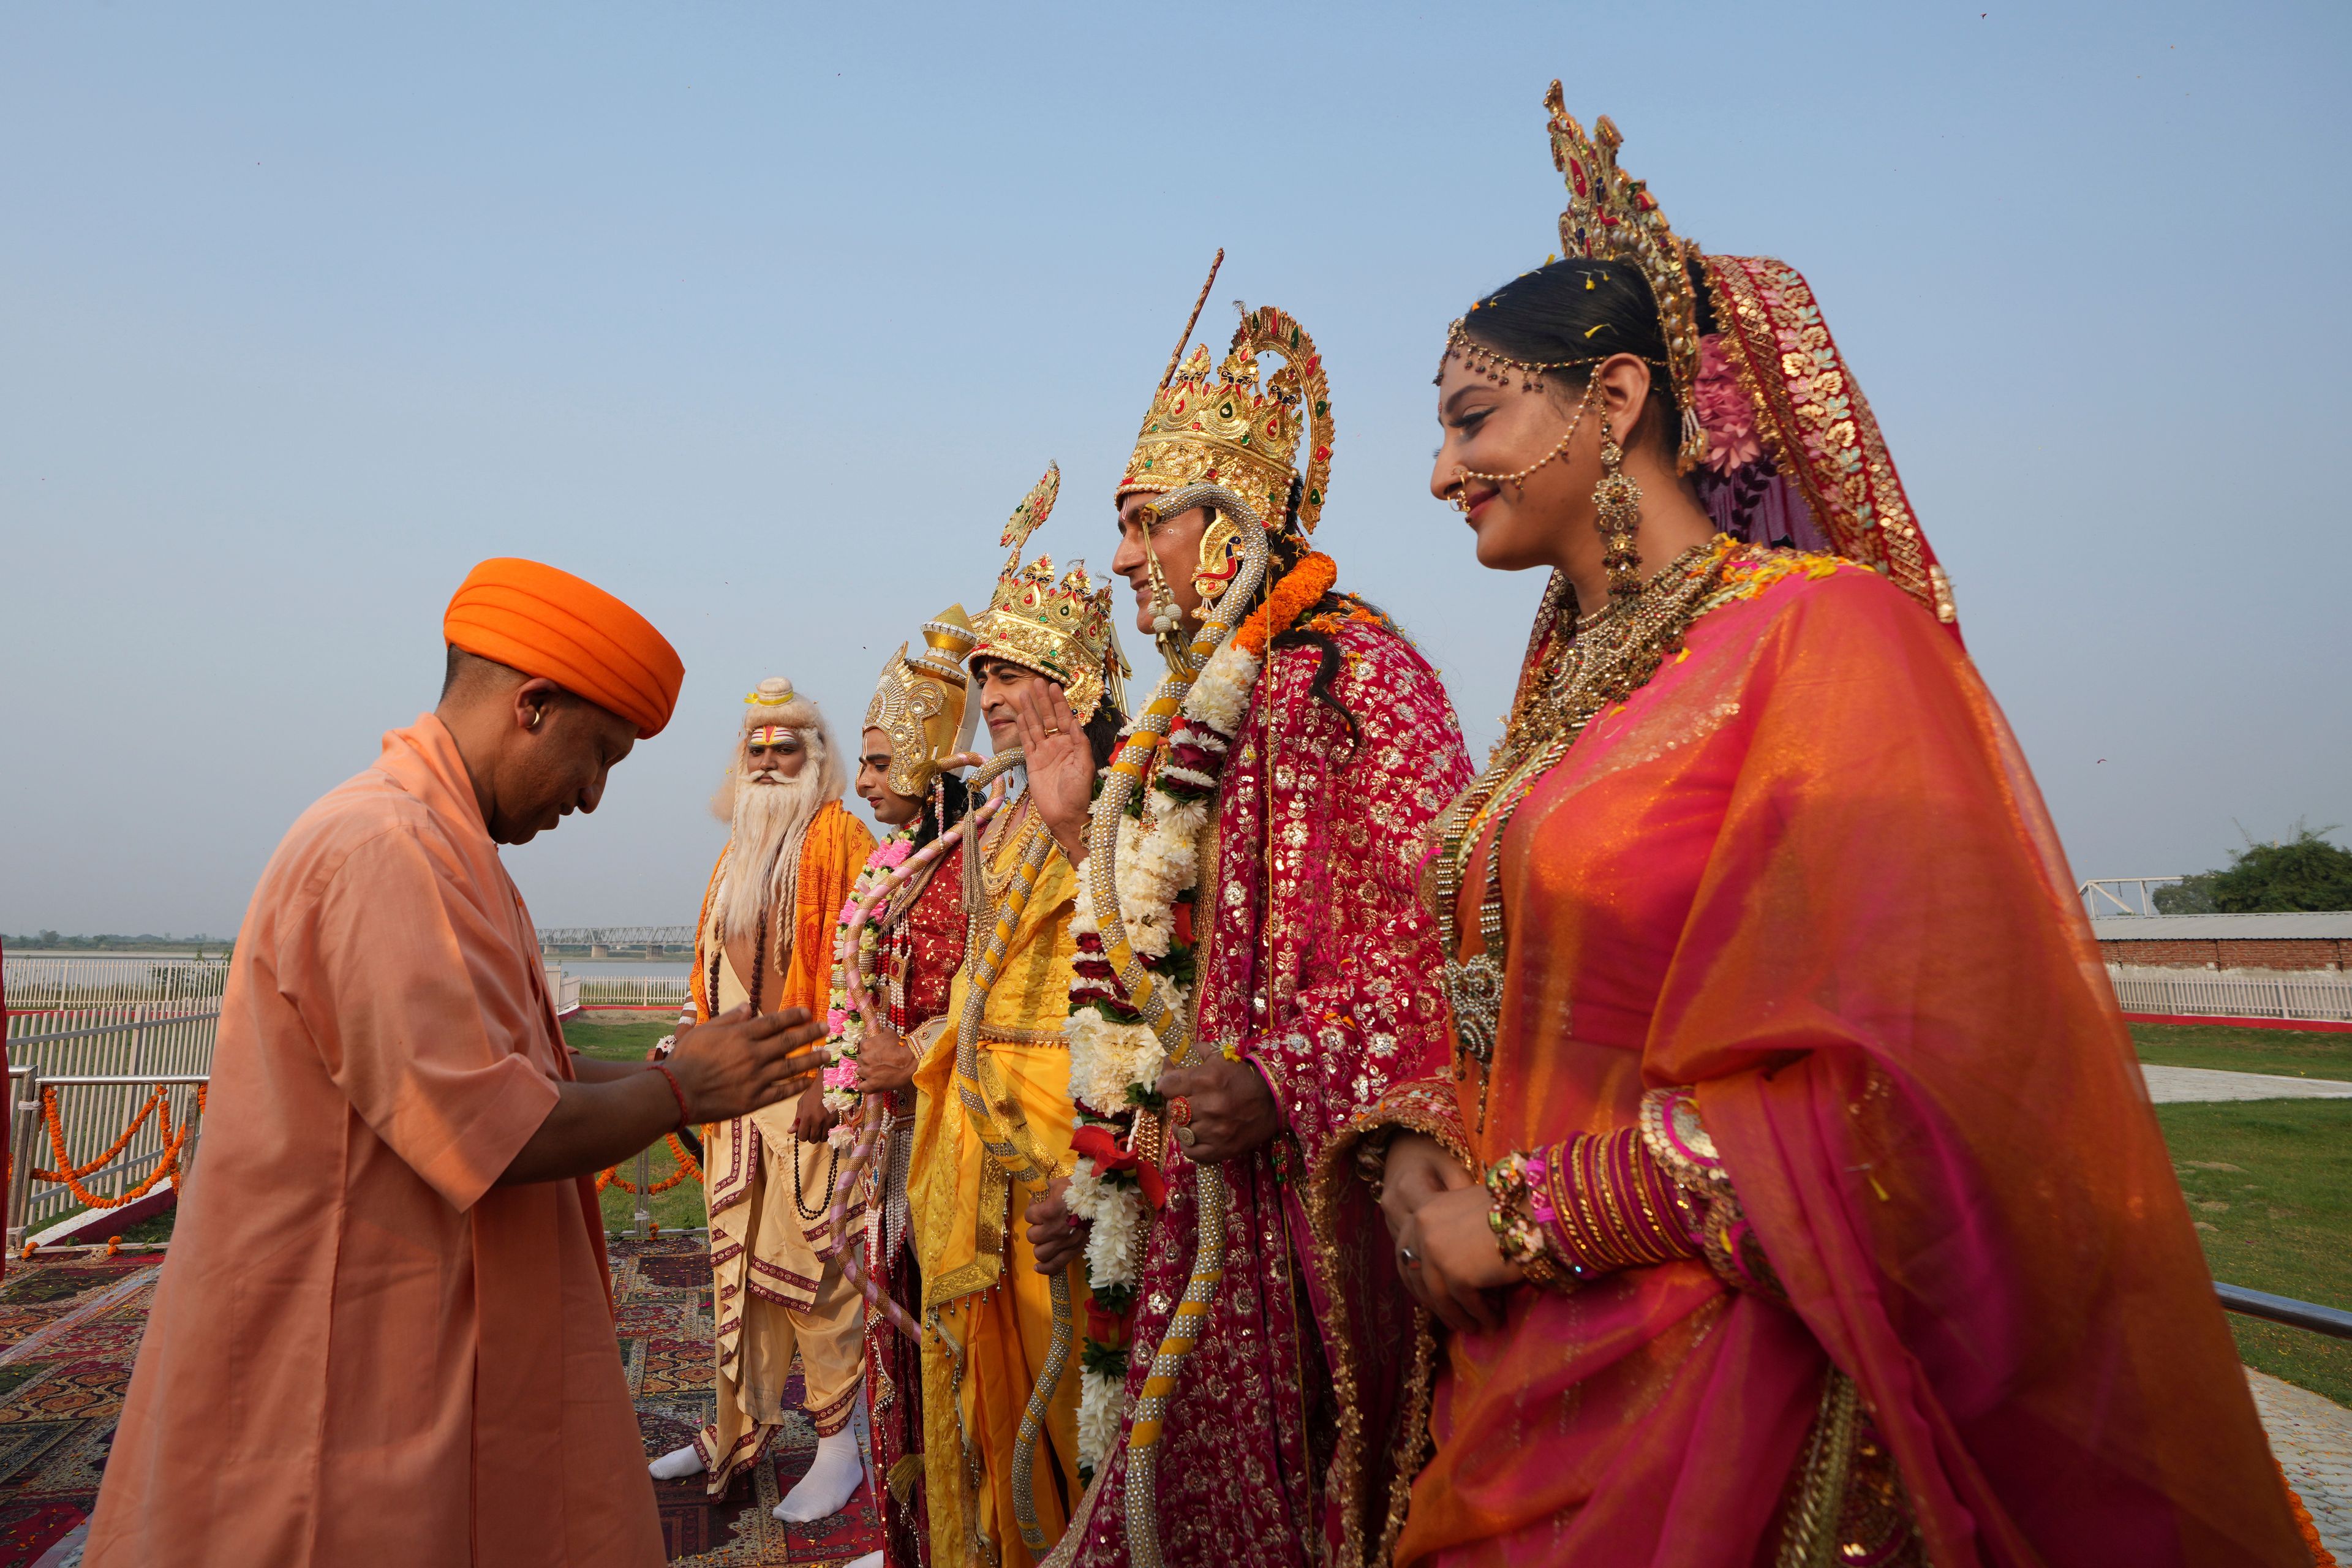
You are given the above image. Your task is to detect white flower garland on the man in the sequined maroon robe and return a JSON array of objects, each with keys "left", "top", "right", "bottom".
[{"left": 1063, "top": 639, "right": 1261, "bottom": 1474}]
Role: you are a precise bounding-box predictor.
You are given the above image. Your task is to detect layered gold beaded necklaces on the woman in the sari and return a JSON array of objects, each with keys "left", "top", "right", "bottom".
[{"left": 1434, "top": 536, "right": 1736, "bottom": 1131}]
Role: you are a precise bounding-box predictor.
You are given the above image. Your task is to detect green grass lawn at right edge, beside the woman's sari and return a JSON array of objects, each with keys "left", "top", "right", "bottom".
[{"left": 2131, "top": 1023, "right": 2352, "bottom": 1403}]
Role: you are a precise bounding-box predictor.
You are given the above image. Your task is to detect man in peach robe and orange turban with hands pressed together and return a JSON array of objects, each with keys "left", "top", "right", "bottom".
[{"left": 82, "top": 559, "right": 821, "bottom": 1568}]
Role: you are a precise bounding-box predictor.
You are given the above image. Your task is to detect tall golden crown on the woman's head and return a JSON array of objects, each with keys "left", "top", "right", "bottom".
[{"left": 1543, "top": 80, "right": 1708, "bottom": 472}]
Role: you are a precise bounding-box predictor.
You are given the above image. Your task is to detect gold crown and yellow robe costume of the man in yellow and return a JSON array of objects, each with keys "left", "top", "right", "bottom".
[{"left": 908, "top": 472, "right": 1125, "bottom": 1568}]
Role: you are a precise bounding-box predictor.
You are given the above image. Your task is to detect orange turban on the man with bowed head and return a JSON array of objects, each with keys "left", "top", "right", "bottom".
[{"left": 442, "top": 557, "right": 687, "bottom": 741}]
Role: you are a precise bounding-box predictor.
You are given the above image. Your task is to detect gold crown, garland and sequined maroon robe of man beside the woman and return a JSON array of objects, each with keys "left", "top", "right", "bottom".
[{"left": 1051, "top": 297, "right": 1470, "bottom": 1568}]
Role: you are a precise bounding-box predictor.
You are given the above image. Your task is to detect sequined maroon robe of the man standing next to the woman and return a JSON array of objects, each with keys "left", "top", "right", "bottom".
[{"left": 1068, "top": 618, "right": 1470, "bottom": 1568}]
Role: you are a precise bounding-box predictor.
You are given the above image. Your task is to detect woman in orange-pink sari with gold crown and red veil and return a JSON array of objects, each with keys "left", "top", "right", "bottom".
[{"left": 1350, "top": 85, "right": 2310, "bottom": 1568}]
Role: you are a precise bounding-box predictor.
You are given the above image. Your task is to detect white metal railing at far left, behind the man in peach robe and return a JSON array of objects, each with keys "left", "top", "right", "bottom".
[{"left": 7, "top": 995, "right": 221, "bottom": 1248}]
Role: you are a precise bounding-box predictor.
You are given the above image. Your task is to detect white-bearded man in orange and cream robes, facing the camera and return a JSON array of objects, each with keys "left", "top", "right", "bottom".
[{"left": 652, "top": 677, "right": 875, "bottom": 1523}]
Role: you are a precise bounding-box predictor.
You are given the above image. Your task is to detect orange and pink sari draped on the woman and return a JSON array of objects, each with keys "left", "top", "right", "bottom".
[{"left": 1397, "top": 557, "right": 2305, "bottom": 1568}]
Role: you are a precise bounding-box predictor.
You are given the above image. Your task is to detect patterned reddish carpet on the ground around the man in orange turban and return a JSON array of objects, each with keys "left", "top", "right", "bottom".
[{"left": 0, "top": 1237, "right": 882, "bottom": 1568}]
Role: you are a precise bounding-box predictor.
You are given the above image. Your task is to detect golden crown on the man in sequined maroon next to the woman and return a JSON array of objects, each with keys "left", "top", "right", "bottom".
[{"left": 1115, "top": 285, "right": 1331, "bottom": 533}]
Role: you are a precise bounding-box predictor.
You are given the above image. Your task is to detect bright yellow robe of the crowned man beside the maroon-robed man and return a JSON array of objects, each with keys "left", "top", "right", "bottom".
[{"left": 908, "top": 802, "right": 1087, "bottom": 1568}]
